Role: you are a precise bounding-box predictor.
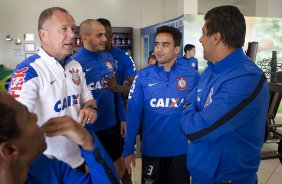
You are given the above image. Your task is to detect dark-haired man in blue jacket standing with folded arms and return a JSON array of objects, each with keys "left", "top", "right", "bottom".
[{"left": 180, "top": 6, "right": 269, "bottom": 184}]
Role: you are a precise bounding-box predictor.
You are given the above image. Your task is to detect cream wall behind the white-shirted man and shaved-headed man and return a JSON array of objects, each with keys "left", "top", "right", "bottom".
[{"left": 0, "top": 0, "right": 183, "bottom": 68}]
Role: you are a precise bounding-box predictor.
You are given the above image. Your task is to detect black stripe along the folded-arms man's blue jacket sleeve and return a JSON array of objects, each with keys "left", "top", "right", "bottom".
[{"left": 186, "top": 74, "right": 266, "bottom": 141}]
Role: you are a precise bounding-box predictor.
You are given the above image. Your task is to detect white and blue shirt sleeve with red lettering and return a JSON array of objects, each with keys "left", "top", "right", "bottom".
[{"left": 8, "top": 64, "right": 39, "bottom": 112}]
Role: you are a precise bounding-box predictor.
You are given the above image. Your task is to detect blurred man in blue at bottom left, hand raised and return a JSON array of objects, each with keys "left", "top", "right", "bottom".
[{"left": 0, "top": 94, "right": 119, "bottom": 184}]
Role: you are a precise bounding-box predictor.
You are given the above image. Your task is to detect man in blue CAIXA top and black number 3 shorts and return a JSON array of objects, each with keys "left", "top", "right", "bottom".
[{"left": 123, "top": 26, "right": 199, "bottom": 184}]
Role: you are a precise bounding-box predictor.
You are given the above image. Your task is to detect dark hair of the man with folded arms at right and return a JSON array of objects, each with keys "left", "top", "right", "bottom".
[{"left": 205, "top": 6, "right": 246, "bottom": 48}]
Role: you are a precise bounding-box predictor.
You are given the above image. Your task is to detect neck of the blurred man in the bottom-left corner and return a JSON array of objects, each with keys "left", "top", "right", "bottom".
[{"left": 0, "top": 164, "right": 28, "bottom": 184}]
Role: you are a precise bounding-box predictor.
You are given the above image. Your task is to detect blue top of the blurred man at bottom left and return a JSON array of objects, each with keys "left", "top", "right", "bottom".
[{"left": 25, "top": 134, "right": 120, "bottom": 184}]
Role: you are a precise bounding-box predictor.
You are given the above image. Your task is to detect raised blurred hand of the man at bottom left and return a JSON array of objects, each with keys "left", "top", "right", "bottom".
[{"left": 41, "top": 116, "right": 95, "bottom": 151}]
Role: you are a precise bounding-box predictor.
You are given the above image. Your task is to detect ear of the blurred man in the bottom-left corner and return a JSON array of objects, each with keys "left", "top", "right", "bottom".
[{"left": 0, "top": 142, "right": 19, "bottom": 161}]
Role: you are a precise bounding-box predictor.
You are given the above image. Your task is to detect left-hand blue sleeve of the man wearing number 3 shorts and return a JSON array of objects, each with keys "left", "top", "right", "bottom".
[{"left": 123, "top": 75, "right": 144, "bottom": 157}]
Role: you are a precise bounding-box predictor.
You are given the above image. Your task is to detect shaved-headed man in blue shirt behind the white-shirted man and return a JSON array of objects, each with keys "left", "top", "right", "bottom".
[{"left": 73, "top": 19, "right": 125, "bottom": 178}]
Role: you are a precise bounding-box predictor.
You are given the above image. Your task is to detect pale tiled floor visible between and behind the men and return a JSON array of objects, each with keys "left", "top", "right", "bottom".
[{"left": 131, "top": 144, "right": 282, "bottom": 184}]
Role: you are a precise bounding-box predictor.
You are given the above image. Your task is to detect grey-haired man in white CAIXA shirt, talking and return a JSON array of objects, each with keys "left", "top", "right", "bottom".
[{"left": 9, "top": 7, "right": 98, "bottom": 171}]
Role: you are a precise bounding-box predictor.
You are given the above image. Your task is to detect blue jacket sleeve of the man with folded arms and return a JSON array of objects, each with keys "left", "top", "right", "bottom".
[{"left": 180, "top": 75, "right": 264, "bottom": 141}]
